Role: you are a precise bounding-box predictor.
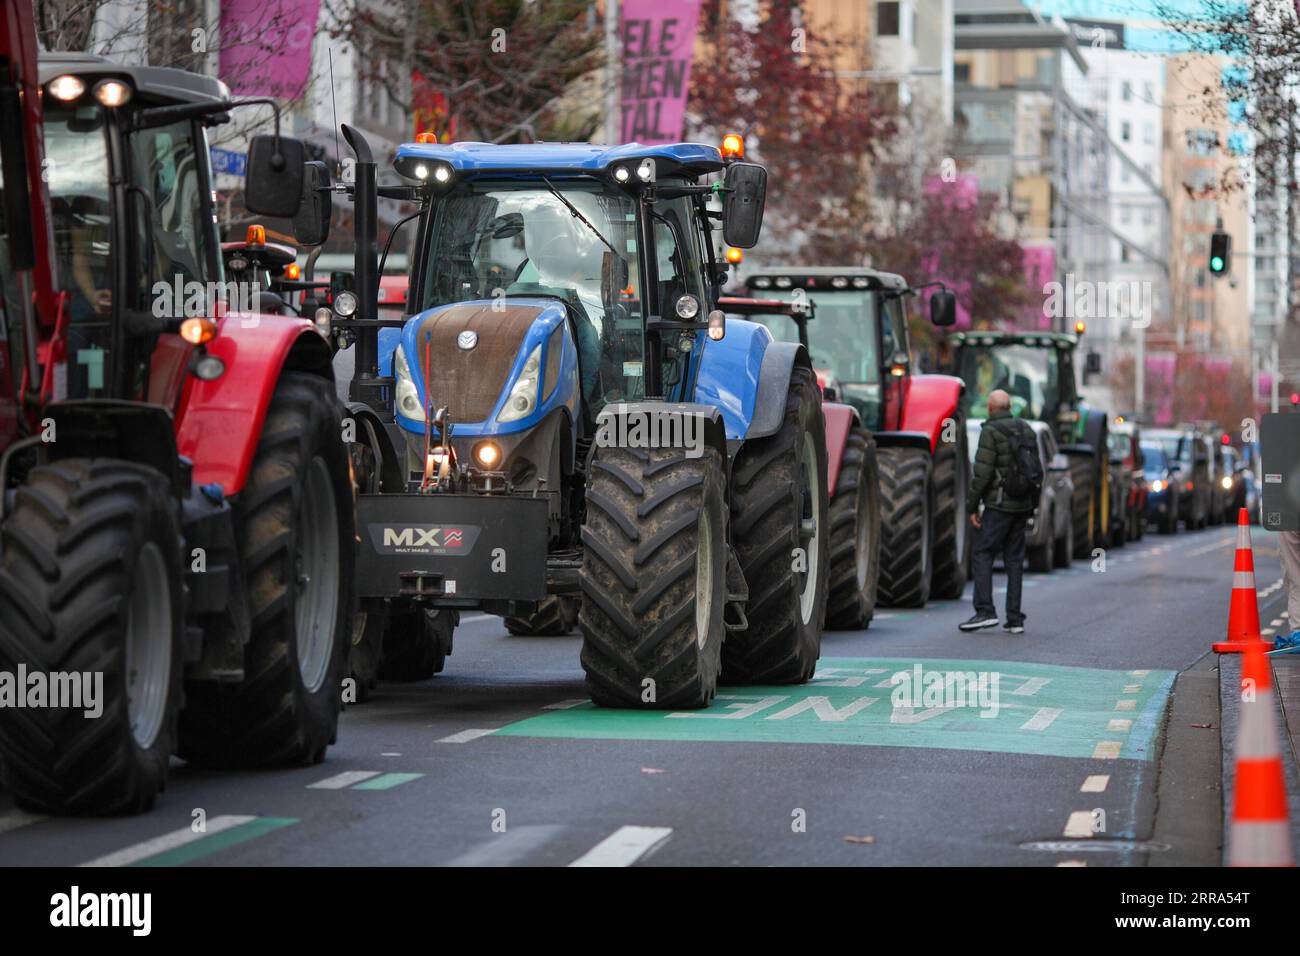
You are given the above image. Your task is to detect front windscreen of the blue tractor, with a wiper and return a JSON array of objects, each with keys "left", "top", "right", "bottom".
[{"left": 416, "top": 178, "right": 645, "bottom": 398}]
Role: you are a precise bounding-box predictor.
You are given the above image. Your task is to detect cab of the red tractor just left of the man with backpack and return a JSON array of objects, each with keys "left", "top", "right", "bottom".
[{"left": 746, "top": 267, "right": 940, "bottom": 431}]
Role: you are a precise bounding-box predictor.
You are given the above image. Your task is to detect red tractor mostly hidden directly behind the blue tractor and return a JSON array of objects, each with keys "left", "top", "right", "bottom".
[{"left": 718, "top": 297, "right": 880, "bottom": 631}]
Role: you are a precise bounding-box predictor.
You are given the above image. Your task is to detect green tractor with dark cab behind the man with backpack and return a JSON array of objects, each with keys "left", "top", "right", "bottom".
[{"left": 948, "top": 330, "right": 1113, "bottom": 558}]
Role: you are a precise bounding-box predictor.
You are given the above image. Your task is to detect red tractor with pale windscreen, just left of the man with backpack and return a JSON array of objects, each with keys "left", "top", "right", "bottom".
[{"left": 745, "top": 267, "right": 970, "bottom": 607}]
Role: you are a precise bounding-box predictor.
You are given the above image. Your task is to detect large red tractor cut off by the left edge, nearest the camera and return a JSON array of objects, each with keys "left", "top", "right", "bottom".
[{"left": 0, "top": 18, "right": 355, "bottom": 814}]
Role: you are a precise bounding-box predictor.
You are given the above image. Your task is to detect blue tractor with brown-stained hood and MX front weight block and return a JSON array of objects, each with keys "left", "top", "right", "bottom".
[{"left": 322, "top": 127, "right": 828, "bottom": 709}]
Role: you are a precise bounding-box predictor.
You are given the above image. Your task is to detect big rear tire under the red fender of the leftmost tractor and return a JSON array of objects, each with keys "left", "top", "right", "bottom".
[{"left": 179, "top": 372, "right": 355, "bottom": 767}]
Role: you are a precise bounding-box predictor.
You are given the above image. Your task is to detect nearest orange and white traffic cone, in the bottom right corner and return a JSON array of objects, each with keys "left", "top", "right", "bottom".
[{"left": 1227, "top": 641, "right": 1295, "bottom": 866}]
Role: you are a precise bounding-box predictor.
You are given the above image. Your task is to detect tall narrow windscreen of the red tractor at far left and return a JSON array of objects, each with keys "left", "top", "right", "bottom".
[{"left": 44, "top": 105, "right": 114, "bottom": 398}]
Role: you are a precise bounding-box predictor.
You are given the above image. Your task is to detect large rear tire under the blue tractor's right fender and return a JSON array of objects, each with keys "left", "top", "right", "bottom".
[{"left": 723, "top": 365, "right": 831, "bottom": 684}]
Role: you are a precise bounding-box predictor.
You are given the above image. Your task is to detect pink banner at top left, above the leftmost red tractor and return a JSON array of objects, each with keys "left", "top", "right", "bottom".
[{"left": 221, "top": 0, "right": 320, "bottom": 100}]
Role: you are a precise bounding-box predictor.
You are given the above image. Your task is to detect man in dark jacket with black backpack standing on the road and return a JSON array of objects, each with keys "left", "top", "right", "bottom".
[{"left": 958, "top": 389, "right": 1037, "bottom": 633}]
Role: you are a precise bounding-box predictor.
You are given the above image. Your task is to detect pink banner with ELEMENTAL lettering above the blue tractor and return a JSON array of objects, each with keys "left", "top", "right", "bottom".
[{"left": 620, "top": 0, "right": 699, "bottom": 146}]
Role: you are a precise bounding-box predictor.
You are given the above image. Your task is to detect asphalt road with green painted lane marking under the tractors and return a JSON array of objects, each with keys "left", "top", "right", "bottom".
[{"left": 0, "top": 528, "right": 1284, "bottom": 866}]
